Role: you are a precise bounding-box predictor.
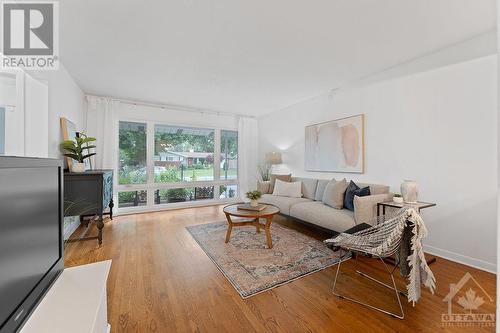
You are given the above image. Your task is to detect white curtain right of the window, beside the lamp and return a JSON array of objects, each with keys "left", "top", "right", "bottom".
[{"left": 238, "top": 117, "right": 259, "bottom": 198}]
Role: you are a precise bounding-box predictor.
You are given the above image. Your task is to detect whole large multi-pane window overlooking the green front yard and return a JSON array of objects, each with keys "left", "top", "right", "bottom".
[{"left": 117, "top": 121, "right": 238, "bottom": 209}]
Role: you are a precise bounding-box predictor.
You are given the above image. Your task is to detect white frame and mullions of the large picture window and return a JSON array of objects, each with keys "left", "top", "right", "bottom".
[{"left": 114, "top": 117, "right": 240, "bottom": 214}]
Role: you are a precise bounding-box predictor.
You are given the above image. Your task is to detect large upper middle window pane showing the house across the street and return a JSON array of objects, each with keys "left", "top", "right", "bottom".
[{"left": 154, "top": 125, "right": 215, "bottom": 183}]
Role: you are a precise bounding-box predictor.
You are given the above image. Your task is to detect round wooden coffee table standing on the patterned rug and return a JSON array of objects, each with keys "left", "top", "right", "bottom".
[{"left": 223, "top": 203, "right": 280, "bottom": 249}]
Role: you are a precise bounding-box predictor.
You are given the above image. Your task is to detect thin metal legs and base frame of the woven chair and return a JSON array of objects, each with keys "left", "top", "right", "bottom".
[{"left": 332, "top": 249, "right": 408, "bottom": 319}]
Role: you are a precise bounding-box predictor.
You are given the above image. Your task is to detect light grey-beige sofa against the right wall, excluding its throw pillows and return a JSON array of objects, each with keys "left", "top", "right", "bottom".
[{"left": 257, "top": 177, "right": 392, "bottom": 233}]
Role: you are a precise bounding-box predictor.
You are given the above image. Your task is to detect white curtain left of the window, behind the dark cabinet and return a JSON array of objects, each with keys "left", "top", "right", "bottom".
[{"left": 85, "top": 96, "right": 120, "bottom": 169}]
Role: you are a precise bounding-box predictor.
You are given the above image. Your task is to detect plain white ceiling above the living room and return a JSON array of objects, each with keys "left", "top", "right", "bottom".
[{"left": 60, "top": 0, "right": 496, "bottom": 116}]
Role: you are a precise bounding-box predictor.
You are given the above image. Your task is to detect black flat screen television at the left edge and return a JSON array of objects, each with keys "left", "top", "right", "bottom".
[{"left": 0, "top": 156, "right": 64, "bottom": 333}]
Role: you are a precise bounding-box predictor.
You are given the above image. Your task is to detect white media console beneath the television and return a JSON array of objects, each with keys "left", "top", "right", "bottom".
[{"left": 21, "top": 260, "right": 111, "bottom": 333}]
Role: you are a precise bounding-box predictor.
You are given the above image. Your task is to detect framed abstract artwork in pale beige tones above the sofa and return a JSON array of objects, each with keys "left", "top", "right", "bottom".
[{"left": 305, "top": 114, "right": 365, "bottom": 173}]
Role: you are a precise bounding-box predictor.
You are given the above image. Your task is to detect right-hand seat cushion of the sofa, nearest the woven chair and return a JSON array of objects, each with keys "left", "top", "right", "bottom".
[{"left": 290, "top": 201, "right": 356, "bottom": 232}]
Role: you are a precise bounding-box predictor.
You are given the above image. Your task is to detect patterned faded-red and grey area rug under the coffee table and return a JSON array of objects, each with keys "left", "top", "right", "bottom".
[{"left": 186, "top": 222, "right": 340, "bottom": 298}]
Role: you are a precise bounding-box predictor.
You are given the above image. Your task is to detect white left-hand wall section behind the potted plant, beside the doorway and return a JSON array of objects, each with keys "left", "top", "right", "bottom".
[{"left": 29, "top": 64, "right": 85, "bottom": 158}]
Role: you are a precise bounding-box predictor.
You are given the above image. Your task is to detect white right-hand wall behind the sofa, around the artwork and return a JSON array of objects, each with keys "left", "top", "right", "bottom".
[{"left": 259, "top": 55, "right": 497, "bottom": 271}]
